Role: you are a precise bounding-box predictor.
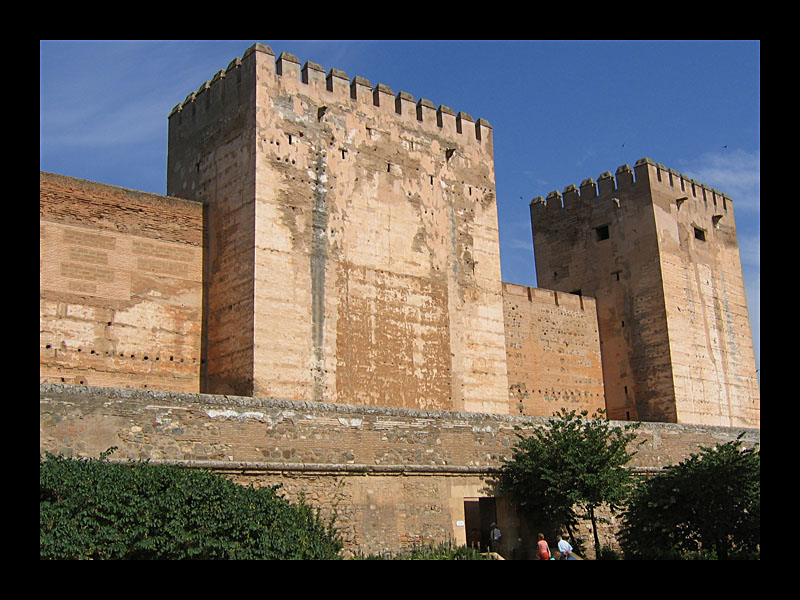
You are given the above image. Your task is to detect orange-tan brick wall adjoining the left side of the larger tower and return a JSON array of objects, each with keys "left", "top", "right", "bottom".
[{"left": 39, "top": 172, "right": 203, "bottom": 392}]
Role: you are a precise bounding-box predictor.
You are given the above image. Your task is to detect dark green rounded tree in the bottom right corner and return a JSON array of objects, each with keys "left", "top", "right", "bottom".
[{"left": 620, "top": 436, "right": 761, "bottom": 560}]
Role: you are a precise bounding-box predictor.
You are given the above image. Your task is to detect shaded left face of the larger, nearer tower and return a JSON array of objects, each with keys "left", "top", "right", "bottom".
[{"left": 167, "top": 52, "right": 256, "bottom": 394}]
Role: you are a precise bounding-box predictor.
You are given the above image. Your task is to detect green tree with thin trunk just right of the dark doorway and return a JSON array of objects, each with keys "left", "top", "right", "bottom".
[{"left": 499, "top": 409, "right": 639, "bottom": 555}]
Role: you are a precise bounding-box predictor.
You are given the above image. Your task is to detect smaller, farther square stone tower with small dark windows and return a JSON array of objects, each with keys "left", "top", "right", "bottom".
[{"left": 531, "top": 158, "right": 760, "bottom": 427}]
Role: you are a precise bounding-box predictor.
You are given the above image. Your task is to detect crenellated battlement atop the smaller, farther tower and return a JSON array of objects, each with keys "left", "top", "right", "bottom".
[{"left": 530, "top": 157, "right": 733, "bottom": 212}]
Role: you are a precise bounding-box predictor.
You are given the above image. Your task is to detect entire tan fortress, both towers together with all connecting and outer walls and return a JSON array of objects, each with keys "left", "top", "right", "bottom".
[{"left": 39, "top": 44, "right": 760, "bottom": 557}]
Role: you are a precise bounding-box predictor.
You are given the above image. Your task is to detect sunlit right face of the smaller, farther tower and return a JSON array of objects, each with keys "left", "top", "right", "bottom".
[{"left": 646, "top": 162, "right": 760, "bottom": 427}]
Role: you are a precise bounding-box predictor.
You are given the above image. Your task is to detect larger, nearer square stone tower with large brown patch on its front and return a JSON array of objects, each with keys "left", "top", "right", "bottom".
[{"left": 167, "top": 44, "right": 508, "bottom": 413}]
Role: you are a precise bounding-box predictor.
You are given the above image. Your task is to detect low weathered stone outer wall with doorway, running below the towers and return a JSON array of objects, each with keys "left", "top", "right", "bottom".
[{"left": 39, "top": 384, "right": 760, "bottom": 552}]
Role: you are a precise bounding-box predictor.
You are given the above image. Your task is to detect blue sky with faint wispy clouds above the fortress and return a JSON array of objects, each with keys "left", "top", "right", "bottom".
[{"left": 39, "top": 40, "right": 761, "bottom": 376}]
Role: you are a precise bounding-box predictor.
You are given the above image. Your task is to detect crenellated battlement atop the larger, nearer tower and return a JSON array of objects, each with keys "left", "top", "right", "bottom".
[{"left": 169, "top": 43, "right": 492, "bottom": 142}]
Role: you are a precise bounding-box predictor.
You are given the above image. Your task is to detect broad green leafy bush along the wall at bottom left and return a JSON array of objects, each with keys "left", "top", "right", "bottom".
[{"left": 39, "top": 449, "right": 342, "bottom": 559}]
